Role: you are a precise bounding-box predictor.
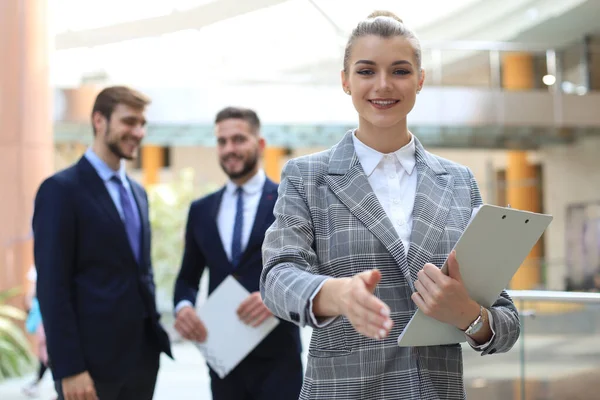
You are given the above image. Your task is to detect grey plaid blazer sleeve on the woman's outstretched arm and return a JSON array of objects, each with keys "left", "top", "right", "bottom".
[{"left": 260, "top": 160, "right": 329, "bottom": 328}]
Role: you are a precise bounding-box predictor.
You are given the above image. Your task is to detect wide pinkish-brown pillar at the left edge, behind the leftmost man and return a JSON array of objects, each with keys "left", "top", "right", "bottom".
[{"left": 0, "top": 0, "right": 53, "bottom": 290}]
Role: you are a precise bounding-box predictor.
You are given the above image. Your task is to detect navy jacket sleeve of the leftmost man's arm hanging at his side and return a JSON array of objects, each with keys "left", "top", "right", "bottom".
[{"left": 32, "top": 177, "right": 86, "bottom": 380}]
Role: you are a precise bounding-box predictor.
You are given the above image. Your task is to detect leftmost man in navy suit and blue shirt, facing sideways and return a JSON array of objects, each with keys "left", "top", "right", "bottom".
[{"left": 33, "top": 86, "right": 171, "bottom": 400}]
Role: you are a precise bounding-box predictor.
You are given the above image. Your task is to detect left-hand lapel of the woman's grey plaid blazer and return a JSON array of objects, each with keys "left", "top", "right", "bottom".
[{"left": 325, "top": 132, "right": 412, "bottom": 287}]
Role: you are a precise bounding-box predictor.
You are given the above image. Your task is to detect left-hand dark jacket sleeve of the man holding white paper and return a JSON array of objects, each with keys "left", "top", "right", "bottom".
[{"left": 173, "top": 203, "right": 206, "bottom": 307}]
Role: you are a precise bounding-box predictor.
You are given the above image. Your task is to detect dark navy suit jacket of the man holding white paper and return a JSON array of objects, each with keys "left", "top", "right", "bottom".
[{"left": 174, "top": 179, "right": 302, "bottom": 357}]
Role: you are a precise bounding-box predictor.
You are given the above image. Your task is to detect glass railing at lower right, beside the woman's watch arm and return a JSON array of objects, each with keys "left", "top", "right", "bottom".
[{"left": 463, "top": 290, "right": 600, "bottom": 400}]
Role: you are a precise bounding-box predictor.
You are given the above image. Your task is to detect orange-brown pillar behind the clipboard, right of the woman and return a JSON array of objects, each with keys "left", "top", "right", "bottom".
[{"left": 502, "top": 53, "right": 542, "bottom": 290}]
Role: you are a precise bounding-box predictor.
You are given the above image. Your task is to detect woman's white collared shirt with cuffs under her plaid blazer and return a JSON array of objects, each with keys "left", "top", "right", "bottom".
[{"left": 309, "top": 131, "right": 495, "bottom": 349}]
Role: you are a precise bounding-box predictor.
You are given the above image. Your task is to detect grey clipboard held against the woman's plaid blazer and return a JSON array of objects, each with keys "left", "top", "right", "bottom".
[{"left": 398, "top": 204, "right": 553, "bottom": 347}]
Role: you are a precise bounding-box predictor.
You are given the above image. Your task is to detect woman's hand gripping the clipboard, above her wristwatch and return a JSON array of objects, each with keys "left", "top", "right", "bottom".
[{"left": 411, "top": 250, "right": 480, "bottom": 330}]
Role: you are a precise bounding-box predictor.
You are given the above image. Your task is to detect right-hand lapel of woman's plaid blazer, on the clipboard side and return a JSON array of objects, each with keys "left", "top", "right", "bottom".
[{"left": 407, "top": 138, "right": 454, "bottom": 285}]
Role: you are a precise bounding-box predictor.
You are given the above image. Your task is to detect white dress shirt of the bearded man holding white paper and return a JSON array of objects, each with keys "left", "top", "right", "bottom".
[{"left": 175, "top": 169, "right": 267, "bottom": 315}]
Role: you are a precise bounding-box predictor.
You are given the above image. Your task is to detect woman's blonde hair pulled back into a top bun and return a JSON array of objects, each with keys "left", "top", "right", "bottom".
[{"left": 344, "top": 10, "right": 421, "bottom": 72}]
